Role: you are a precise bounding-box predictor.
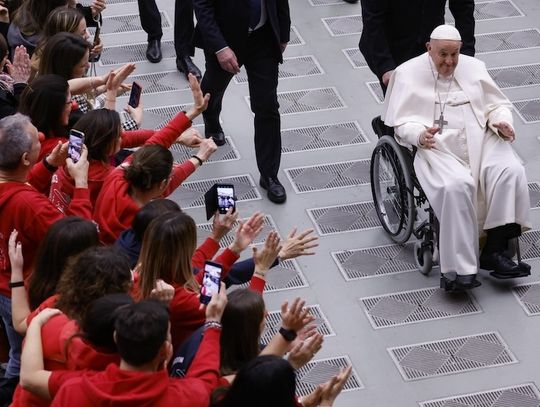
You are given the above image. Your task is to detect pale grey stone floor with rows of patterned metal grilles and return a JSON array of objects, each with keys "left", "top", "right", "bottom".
[{"left": 98, "top": 0, "right": 540, "bottom": 407}]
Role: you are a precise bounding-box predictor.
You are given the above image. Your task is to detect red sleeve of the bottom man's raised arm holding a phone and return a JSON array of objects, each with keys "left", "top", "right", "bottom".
[{"left": 186, "top": 328, "right": 221, "bottom": 393}]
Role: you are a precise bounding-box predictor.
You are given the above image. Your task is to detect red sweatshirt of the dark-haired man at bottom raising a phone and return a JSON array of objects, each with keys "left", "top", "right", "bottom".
[{"left": 49, "top": 328, "right": 221, "bottom": 407}]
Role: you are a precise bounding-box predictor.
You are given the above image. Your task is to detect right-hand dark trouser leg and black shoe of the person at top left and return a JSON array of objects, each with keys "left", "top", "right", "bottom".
[{"left": 174, "top": 0, "right": 202, "bottom": 81}]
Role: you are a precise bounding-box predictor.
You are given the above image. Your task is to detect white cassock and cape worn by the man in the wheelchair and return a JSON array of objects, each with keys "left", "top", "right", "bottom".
[{"left": 383, "top": 53, "right": 531, "bottom": 275}]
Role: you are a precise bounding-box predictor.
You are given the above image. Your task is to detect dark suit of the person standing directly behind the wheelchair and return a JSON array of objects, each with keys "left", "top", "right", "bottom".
[{"left": 359, "top": 0, "right": 474, "bottom": 80}]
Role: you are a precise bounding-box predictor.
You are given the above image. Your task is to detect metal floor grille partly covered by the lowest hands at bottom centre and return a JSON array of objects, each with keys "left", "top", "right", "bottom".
[{"left": 296, "top": 356, "right": 364, "bottom": 397}]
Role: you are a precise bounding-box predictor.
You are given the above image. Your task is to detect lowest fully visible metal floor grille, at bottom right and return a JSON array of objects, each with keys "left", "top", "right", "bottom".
[{"left": 388, "top": 332, "right": 517, "bottom": 381}]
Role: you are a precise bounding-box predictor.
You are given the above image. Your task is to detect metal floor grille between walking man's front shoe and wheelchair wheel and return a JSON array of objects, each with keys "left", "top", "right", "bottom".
[{"left": 285, "top": 160, "right": 371, "bottom": 193}]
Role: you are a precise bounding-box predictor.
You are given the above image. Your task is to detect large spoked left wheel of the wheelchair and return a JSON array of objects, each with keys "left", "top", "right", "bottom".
[{"left": 370, "top": 136, "right": 416, "bottom": 244}]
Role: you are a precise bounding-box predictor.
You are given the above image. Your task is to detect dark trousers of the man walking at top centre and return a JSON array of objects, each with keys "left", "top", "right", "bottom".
[{"left": 201, "top": 24, "right": 281, "bottom": 177}]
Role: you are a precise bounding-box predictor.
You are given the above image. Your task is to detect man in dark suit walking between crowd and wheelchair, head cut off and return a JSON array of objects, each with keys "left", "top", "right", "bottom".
[{"left": 193, "top": 0, "right": 291, "bottom": 203}]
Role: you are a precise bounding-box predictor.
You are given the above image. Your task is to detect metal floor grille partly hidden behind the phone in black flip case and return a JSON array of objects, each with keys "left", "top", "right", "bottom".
[{"left": 171, "top": 174, "right": 261, "bottom": 208}]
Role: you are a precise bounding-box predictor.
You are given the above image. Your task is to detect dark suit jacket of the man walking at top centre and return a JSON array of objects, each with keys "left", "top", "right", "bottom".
[{"left": 193, "top": 0, "right": 291, "bottom": 60}]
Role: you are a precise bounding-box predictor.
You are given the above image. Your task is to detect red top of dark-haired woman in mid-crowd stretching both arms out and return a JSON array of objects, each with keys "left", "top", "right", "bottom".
[{"left": 94, "top": 113, "right": 195, "bottom": 244}]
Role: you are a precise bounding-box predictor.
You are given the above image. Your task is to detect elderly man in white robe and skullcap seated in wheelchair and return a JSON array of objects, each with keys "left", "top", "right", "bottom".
[{"left": 372, "top": 25, "right": 531, "bottom": 291}]
